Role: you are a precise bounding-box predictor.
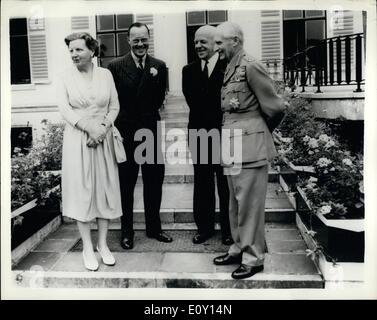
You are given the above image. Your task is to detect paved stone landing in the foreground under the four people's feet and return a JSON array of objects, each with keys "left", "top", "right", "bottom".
[{"left": 12, "top": 223, "right": 324, "bottom": 290}]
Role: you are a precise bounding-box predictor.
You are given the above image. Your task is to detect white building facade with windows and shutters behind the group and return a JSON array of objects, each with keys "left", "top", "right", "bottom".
[{"left": 9, "top": 10, "right": 364, "bottom": 146}]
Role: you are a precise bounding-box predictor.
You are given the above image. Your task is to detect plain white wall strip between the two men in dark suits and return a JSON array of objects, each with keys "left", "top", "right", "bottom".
[{"left": 154, "top": 12, "right": 187, "bottom": 95}]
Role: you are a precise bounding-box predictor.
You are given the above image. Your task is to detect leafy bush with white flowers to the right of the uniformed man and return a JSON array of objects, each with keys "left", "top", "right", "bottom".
[{"left": 275, "top": 94, "right": 364, "bottom": 218}]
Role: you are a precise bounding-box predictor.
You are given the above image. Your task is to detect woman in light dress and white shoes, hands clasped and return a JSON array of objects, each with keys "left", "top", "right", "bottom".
[{"left": 58, "top": 32, "right": 122, "bottom": 271}]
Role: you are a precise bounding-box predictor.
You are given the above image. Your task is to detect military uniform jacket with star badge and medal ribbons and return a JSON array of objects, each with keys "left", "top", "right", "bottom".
[{"left": 221, "top": 50, "right": 285, "bottom": 167}]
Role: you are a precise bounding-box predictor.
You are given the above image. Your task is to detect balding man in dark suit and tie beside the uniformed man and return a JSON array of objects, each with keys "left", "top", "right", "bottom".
[{"left": 182, "top": 25, "right": 233, "bottom": 245}]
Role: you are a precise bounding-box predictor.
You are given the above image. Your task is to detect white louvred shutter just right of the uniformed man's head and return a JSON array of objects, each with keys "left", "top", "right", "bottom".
[{"left": 261, "top": 10, "right": 282, "bottom": 78}]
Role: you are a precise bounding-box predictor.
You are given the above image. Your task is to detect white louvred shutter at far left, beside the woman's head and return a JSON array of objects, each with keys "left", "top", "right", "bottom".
[{"left": 28, "top": 18, "right": 49, "bottom": 83}]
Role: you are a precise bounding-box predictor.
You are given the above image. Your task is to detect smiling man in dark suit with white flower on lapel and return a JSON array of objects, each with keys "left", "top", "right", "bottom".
[{"left": 108, "top": 22, "right": 172, "bottom": 249}]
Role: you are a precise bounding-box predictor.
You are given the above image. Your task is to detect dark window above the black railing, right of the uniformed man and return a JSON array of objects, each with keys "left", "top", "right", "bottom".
[{"left": 283, "top": 10, "right": 326, "bottom": 65}]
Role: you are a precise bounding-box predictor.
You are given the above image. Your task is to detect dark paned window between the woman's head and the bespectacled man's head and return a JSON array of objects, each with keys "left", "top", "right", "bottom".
[{"left": 96, "top": 14, "right": 134, "bottom": 67}]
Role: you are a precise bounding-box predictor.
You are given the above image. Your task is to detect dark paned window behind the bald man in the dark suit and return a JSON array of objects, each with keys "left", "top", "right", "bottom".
[{"left": 186, "top": 10, "right": 228, "bottom": 63}]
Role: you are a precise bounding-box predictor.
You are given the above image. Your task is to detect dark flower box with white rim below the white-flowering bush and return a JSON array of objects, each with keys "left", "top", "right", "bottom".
[{"left": 296, "top": 187, "right": 365, "bottom": 262}]
